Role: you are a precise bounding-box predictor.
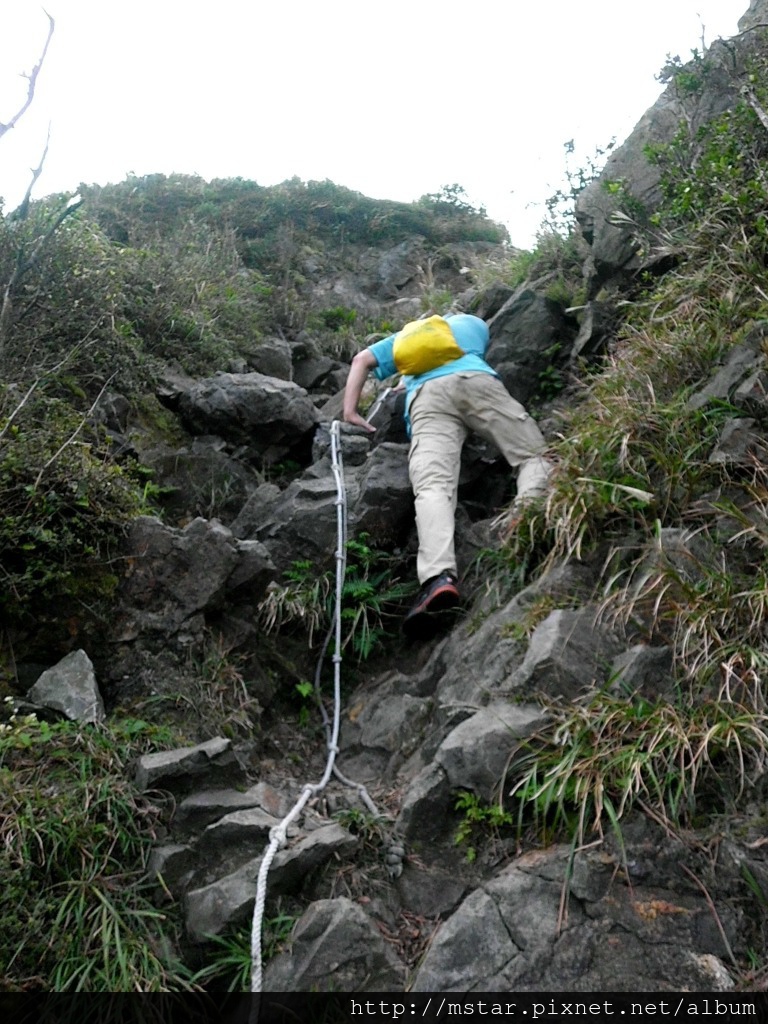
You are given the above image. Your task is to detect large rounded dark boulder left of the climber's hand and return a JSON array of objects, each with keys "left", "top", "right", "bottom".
[{"left": 178, "top": 373, "right": 317, "bottom": 463}]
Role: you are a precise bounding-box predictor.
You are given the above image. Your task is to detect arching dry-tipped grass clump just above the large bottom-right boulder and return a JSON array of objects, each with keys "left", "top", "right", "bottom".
[{"left": 510, "top": 685, "right": 768, "bottom": 844}]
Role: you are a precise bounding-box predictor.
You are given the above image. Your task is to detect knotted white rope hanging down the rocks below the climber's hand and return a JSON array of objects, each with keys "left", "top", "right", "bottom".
[{"left": 251, "top": 420, "right": 347, "bottom": 992}]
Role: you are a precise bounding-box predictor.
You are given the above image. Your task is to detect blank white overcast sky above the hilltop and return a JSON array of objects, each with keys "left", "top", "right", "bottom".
[{"left": 0, "top": 0, "right": 750, "bottom": 246}]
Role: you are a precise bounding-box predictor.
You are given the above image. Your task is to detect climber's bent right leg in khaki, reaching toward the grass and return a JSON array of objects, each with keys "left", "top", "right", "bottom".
[{"left": 457, "top": 374, "right": 552, "bottom": 502}]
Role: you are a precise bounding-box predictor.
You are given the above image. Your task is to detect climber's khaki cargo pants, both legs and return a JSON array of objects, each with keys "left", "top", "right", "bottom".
[{"left": 409, "top": 372, "right": 551, "bottom": 583}]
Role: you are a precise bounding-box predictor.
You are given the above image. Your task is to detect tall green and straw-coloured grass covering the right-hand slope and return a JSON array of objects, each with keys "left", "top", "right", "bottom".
[{"left": 495, "top": 48, "right": 768, "bottom": 843}]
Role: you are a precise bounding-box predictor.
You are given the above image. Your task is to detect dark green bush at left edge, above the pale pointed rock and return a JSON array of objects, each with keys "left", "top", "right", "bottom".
[{"left": 0, "top": 387, "right": 147, "bottom": 638}]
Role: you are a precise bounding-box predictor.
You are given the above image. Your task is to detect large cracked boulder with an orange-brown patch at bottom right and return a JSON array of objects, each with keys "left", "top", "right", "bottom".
[{"left": 412, "top": 848, "right": 739, "bottom": 992}]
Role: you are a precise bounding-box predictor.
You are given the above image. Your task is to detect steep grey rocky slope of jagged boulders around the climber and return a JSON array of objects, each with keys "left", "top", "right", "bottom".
[{"left": 10, "top": 0, "right": 768, "bottom": 992}]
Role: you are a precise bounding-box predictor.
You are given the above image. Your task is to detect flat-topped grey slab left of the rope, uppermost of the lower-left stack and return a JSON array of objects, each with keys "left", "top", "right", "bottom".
[{"left": 133, "top": 737, "right": 246, "bottom": 795}]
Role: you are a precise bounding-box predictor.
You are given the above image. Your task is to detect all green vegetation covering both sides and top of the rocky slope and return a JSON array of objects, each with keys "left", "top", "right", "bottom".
[{"left": 0, "top": 28, "right": 768, "bottom": 990}]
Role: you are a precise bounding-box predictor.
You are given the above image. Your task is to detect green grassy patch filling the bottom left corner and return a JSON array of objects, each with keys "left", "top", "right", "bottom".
[{"left": 0, "top": 715, "right": 193, "bottom": 992}]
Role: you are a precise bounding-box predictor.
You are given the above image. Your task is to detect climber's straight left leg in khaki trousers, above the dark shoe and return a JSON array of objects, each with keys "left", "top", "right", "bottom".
[{"left": 409, "top": 375, "right": 467, "bottom": 583}]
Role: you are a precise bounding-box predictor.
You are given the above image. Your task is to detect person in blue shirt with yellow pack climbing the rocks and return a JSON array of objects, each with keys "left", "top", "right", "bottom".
[{"left": 343, "top": 313, "right": 551, "bottom": 637}]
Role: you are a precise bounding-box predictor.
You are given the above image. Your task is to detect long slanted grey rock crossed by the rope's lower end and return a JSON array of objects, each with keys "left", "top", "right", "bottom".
[{"left": 185, "top": 824, "right": 357, "bottom": 942}]
